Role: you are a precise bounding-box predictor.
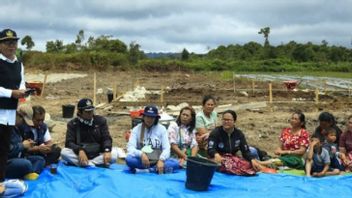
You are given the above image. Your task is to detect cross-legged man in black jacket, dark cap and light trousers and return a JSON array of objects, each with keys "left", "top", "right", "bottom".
[{"left": 61, "top": 98, "right": 118, "bottom": 167}]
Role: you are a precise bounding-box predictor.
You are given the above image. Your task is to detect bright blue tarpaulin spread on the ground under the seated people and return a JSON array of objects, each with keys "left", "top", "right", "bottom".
[{"left": 25, "top": 164, "right": 352, "bottom": 198}]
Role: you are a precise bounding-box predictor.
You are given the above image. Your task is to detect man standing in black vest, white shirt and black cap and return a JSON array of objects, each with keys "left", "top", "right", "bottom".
[{"left": 0, "top": 29, "right": 25, "bottom": 194}]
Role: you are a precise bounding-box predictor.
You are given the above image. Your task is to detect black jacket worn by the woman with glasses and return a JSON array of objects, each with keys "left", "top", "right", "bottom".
[{"left": 208, "top": 126, "right": 253, "bottom": 161}]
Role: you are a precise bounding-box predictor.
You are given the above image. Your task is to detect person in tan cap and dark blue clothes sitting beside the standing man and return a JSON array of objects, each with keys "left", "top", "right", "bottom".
[{"left": 6, "top": 105, "right": 45, "bottom": 180}]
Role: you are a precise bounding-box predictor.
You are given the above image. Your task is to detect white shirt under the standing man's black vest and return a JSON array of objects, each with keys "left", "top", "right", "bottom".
[{"left": 0, "top": 53, "right": 26, "bottom": 126}]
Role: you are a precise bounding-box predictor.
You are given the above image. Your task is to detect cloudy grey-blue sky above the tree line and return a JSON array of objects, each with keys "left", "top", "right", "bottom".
[{"left": 0, "top": 0, "right": 352, "bottom": 53}]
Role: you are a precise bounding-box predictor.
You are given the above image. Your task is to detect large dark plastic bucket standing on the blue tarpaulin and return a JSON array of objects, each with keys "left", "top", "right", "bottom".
[{"left": 186, "top": 157, "right": 219, "bottom": 191}]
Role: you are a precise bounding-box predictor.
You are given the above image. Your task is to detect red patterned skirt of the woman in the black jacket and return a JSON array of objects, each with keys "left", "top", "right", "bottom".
[{"left": 220, "top": 154, "right": 256, "bottom": 175}]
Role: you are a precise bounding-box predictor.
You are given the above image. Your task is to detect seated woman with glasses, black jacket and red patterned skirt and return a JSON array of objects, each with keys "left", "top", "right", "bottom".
[{"left": 208, "top": 110, "right": 262, "bottom": 175}]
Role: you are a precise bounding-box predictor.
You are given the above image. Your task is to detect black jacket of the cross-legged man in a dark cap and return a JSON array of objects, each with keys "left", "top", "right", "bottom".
[{"left": 65, "top": 115, "right": 112, "bottom": 154}]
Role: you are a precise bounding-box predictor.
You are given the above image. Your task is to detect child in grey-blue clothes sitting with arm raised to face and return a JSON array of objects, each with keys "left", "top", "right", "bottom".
[{"left": 305, "top": 138, "right": 340, "bottom": 177}]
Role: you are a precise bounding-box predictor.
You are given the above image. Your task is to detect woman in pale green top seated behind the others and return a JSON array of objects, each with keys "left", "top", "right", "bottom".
[{"left": 196, "top": 95, "right": 217, "bottom": 156}]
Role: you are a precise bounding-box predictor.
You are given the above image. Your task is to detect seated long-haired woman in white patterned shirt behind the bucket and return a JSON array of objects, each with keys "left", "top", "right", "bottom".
[{"left": 168, "top": 107, "right": 198, "bottom": 166}]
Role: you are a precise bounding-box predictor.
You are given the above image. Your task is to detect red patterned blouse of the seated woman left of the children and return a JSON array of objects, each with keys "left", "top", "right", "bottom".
[{"left": 280, "top": 128, "right": 309, "bottom": 150}]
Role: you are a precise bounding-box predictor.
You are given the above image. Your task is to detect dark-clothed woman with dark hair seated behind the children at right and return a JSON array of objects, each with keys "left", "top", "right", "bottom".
[{"left": 312, "top": 112, "right": 342, "bottom": 144}]
